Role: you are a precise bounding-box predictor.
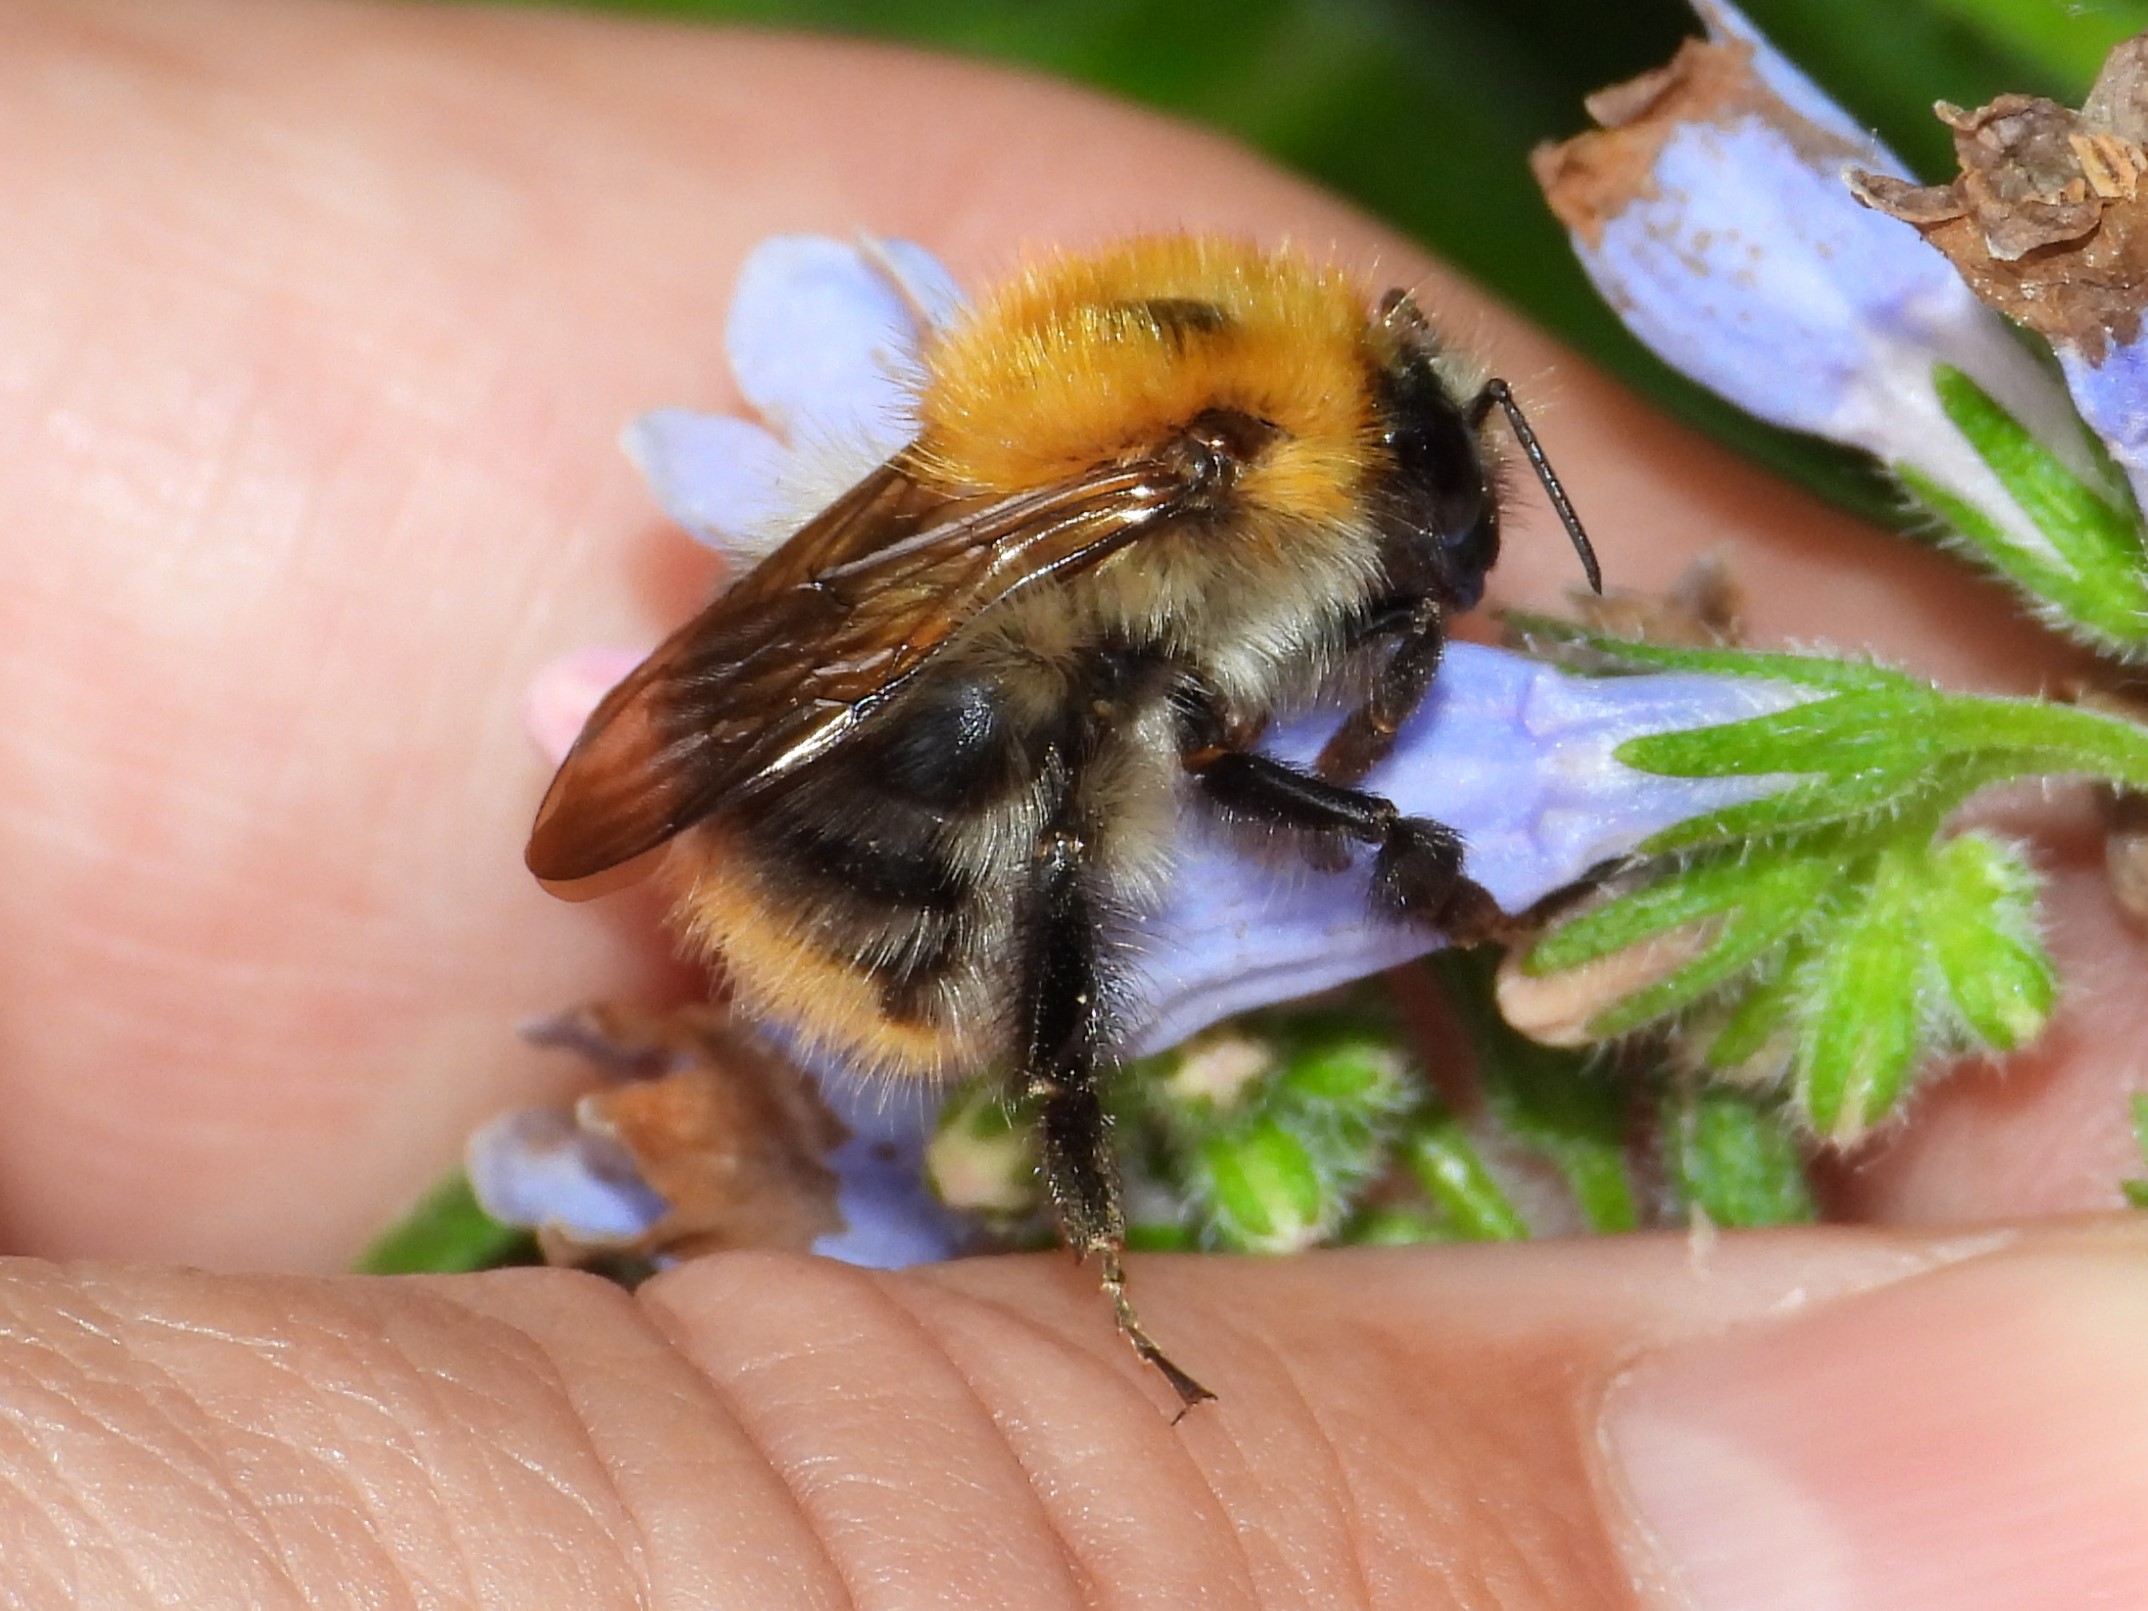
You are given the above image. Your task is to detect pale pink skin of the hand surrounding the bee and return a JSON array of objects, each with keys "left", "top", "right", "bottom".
[{"left": 0, "top": 0, "right": 2148, "bottom": 1609}]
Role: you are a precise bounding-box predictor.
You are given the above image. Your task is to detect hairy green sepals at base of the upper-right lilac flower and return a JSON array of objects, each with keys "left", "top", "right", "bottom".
[{"left": 1892, "top": 363, "right": 2148, "bottom": 655}]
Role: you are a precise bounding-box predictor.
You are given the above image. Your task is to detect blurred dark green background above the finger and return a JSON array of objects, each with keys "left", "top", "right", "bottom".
[{"left": 457, "top": 0, "right": 2148, "bottom": 518}]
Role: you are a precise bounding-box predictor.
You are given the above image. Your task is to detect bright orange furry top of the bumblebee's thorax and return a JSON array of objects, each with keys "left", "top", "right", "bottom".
[{"left": 915, "top": 234, "right": 1375, "bottom": 518}]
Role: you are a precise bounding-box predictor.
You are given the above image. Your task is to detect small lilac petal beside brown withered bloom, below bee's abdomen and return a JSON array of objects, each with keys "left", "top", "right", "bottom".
[{"left": 464, "top": 1108, "right": 668, "bottom": 1246}]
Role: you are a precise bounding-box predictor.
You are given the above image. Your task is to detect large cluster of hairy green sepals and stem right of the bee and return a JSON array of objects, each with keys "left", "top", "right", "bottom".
[{"left": 1521, "top": 623, "right": 2148, "bottom": 1143}]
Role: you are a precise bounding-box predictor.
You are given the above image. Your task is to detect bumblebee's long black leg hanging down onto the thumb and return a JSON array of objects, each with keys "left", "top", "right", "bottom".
[{"left": 1020, "top": 829, "right": 1216, "bottom": 1413}]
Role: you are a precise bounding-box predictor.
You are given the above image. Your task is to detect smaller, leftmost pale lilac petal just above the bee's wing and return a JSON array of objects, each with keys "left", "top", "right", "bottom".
[{"left": 619, "top": 408, "right": 790, "bottom": 567}]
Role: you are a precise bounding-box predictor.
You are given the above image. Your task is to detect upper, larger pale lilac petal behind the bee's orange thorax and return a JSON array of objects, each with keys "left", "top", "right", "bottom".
[{"left": 724, "top": 234, "right": 921, "bottom": 466}]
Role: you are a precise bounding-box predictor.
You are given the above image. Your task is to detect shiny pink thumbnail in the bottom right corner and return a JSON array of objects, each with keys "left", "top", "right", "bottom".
[{"left": 1602, "top": 1233, "right": 2148, "bottom": 1611}]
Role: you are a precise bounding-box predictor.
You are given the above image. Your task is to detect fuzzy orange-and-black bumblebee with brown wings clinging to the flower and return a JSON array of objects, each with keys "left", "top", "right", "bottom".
[{"left": 526, "top": 236, "right": 1598, "bottom": 1405}]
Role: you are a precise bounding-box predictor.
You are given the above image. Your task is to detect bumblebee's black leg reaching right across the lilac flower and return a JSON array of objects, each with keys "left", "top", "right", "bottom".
[{"left": 1188, "top": 750, "right": 1506, "bottom": 945}]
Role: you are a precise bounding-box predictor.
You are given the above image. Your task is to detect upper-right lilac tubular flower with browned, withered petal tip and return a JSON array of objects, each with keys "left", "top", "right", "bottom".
[{"left": 1536, "top": 0, "right": 2092, "bottom": 558}]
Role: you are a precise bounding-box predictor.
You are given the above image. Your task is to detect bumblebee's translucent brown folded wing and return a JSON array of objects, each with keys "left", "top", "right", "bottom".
[{"left": 524, "top": 458, "right": 1199, "bottom": 883}]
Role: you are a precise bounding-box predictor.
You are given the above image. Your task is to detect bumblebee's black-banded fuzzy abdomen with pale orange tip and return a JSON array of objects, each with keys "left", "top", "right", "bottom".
[{"left": 677, "top": 651, "right": 1179, "bottom": 1078}]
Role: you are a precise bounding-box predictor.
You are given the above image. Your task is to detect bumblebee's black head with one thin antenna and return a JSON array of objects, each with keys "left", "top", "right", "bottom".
[{"left": 1373, "top": 290, "right": 1602, "bottom": 610}]
